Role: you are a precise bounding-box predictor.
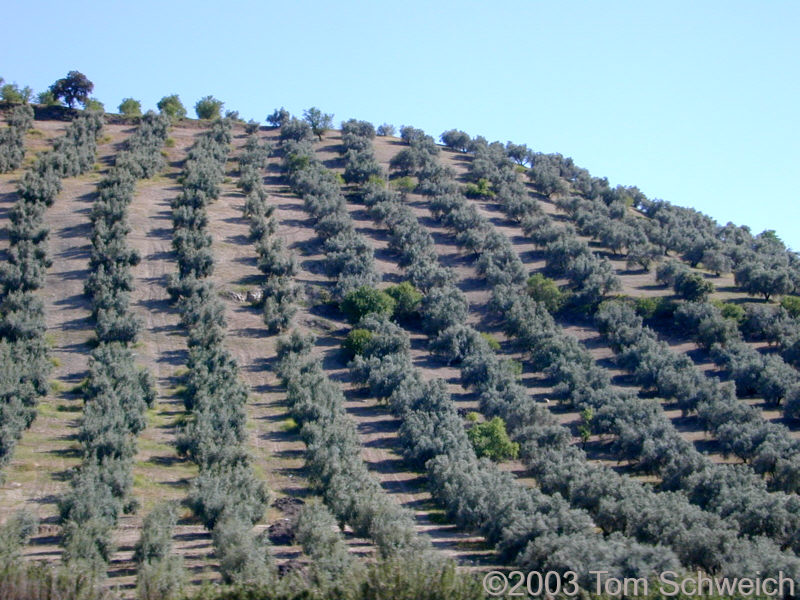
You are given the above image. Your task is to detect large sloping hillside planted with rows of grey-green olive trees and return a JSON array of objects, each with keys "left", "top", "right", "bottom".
[{"left": 0, "top": 109, "right": 800, "bottom": 596}]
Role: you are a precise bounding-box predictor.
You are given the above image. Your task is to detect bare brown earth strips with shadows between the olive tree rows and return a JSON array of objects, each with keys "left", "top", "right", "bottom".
[{"left": 0, "top": 121, "right": 800, "bottom": 595}]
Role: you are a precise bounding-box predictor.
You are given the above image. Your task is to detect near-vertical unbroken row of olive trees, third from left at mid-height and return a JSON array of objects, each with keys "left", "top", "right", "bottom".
[{"left": 168, "top": 119, "right": 273, "bottom": 583}]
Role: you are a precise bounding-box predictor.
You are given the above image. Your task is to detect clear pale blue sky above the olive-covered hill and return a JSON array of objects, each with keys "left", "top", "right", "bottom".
[{"left": 0, "top": 0, "right": 800, "bottom": 249}]
